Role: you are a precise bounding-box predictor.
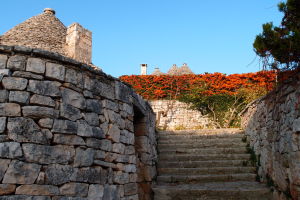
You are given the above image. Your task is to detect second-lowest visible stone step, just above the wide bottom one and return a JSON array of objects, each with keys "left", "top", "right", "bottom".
[{"left": 157, "top": 173, "right": 256, "bottom": 184}]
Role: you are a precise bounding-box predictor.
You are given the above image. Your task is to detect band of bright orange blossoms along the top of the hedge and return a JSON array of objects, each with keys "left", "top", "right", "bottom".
[{"left": 120, "top": 71, "right": 276, "bottom": 100}]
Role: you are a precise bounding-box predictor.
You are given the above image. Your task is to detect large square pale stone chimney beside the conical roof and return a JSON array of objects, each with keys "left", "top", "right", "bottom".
[{"left": 65, "top": 23, "right": 92, "bottom": 64}]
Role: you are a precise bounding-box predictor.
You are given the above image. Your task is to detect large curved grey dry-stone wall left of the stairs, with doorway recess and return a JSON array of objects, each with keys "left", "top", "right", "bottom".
[{"left": 0, "top": 46, "right": 157, "bottom": 200}]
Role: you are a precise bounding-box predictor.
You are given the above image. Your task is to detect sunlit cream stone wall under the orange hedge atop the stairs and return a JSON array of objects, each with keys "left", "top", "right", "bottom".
[{"left": 149, "top": 100, "right": 214, "bottom": 130}]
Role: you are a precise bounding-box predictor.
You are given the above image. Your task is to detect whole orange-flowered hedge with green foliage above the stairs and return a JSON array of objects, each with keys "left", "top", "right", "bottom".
[{"left": 120, "top": 71, "right": 276, "bottom": 127}]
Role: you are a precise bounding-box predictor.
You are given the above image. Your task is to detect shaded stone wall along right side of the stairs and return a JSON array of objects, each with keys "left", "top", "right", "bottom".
[{"left": 242, "top": 76, "right": 300, "bottom": 199}]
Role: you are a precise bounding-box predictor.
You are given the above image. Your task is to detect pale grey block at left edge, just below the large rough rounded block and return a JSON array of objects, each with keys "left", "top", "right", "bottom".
[{"left": 0, "top": 142, "right": 23, "bottom": 158}]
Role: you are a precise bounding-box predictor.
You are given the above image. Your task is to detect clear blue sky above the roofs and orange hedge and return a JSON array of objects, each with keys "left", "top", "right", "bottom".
[{"left": 0, "top": 0, "right": 282, "bottom": 77}]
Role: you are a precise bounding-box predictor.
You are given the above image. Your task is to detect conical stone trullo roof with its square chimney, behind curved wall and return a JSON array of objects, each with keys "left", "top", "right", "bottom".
[{"left": 0, "top": 8, "right": 92, "bottom": 64}]
